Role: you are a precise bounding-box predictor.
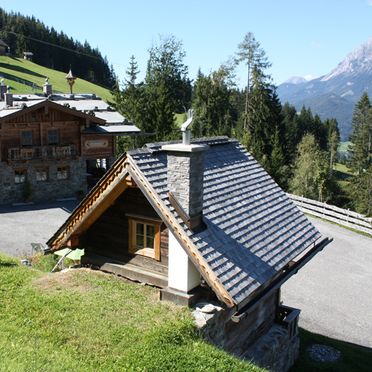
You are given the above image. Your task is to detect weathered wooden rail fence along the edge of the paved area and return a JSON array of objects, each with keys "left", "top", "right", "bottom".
[{"left": 287, "top": 194, "right": 372, "bottom": 236}]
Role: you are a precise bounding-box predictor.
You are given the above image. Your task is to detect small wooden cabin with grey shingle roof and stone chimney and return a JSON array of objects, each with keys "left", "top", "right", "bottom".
[{"left": 48, "top": 131, "right": 329, "bottom": 369}]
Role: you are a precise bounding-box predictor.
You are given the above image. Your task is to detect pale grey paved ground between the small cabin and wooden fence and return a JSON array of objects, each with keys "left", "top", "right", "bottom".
[{"left": 282, "top": 218, "right": 372, "bottom": 347}]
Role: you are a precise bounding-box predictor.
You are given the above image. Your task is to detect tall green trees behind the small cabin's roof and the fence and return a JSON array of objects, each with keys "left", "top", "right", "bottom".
[{"left": 113, "top": 32, "right": 372, "bottom": 215}]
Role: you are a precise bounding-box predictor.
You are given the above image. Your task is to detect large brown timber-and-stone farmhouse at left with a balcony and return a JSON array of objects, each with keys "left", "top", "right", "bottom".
[{"left": 0, "top": 81, "right": 139, "bottom": 204}]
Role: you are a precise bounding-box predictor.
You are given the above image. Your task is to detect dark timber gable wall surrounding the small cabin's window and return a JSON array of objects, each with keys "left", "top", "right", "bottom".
[{"left": 80, "top": 188, "right": 168, "bottom": 273}]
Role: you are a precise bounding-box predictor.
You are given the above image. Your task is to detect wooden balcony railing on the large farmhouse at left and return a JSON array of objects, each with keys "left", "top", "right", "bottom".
[{"left": 8, "top": 145, "right": 77, "bottom": 161}]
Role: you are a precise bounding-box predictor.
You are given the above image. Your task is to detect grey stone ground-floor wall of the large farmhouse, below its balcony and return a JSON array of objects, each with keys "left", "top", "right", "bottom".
[{"left": 0, "top": 158, "right": 87, "bottom": 204}]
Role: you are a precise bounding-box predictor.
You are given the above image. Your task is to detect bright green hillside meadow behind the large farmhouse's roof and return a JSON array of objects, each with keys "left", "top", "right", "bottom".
[{"left": 0, "top": 56, "right": 111, "bottom": 101}]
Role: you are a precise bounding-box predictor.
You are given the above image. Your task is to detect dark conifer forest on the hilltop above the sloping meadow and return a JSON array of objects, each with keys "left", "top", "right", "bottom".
[{"left": 0, "top": 8, "right": 115, "bottom": 89}]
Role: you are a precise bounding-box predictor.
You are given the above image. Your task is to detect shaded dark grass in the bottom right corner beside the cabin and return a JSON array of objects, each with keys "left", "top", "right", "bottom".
[{"left": 290, "top": 328, "right": 372, "bottom": 372}]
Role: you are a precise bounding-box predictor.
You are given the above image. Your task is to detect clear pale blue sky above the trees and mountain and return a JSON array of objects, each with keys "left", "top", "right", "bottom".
[{"left": 0, "top": 0, "right": 372, "bottom": 85}]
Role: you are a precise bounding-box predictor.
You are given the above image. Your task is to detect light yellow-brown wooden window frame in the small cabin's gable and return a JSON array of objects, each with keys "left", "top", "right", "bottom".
[{"left": 128, "top": 217, "right": 162, "bottom": 261}]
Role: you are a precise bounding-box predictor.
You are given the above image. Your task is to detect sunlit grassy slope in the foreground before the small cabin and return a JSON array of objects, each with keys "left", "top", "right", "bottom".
[{"left": 0, "top": 255, "right": 260, "bottom": 371}]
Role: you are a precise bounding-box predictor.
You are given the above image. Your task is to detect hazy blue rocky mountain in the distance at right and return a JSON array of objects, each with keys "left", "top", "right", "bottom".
[{"left": 278, "top": 38, "right": 372, "bottom": 141}]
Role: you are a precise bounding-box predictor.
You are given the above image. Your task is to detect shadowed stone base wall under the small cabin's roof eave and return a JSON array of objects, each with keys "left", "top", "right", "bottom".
[{"left": 193, "top": 300, "right": 300, "bottom": 372}]
